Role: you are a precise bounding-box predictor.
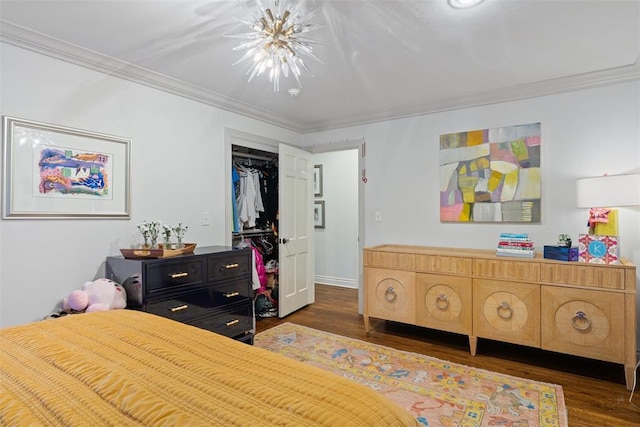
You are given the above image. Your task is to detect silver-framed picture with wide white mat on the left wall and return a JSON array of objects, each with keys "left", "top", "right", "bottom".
[{"left": 2, "top": 116, "right": 131, "bottom": 219}]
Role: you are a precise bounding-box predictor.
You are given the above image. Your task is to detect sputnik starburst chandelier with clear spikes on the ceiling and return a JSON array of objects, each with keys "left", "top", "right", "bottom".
[{"left": 228, "top": 0, "right": 322, "bottom": 92}]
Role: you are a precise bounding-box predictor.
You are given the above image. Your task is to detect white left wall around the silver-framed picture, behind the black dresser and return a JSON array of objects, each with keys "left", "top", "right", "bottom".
[{"left": 0, "top": 44, "right": 300, "bottom": 326}]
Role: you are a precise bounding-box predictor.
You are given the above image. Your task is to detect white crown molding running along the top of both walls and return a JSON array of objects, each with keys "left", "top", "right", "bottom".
[{"left": 0, "top": 20, "right": 640, "bottom": 133}]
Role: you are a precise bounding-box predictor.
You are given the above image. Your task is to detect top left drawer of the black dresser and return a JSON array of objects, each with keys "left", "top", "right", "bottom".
[{"left": 144, "top": 258, "right": 204, "bottom": 293}]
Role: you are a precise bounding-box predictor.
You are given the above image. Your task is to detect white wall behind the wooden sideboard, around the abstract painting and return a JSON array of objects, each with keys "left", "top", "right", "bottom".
[{"left": 303, "top": 82, "right": 640, "bottom": 352}]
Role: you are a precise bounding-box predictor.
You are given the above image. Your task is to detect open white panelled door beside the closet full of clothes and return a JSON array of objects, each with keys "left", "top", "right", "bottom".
[{"left": 278, "top": 144, "right": 315, "bottom": 317}]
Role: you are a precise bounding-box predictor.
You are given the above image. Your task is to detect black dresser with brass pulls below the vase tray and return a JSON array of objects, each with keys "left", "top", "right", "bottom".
[{"left": 106, "top": 246, "right": 254, "bottom": 344}]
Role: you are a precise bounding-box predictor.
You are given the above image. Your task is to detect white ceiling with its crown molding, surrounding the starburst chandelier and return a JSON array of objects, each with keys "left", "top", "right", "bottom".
[{"left": 0, "top": 0, "right": 640, "bottom": 132}]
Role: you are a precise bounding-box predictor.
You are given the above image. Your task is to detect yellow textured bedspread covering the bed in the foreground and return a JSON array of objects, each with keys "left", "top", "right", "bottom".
[{"left": 0, "top": 310, "right": 416, "bottom": 426}]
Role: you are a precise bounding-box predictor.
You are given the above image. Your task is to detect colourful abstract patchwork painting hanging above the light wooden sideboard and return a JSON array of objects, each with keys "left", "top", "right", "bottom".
[{"left": 439, "top": 123, "right": 541, "bottom": 223}]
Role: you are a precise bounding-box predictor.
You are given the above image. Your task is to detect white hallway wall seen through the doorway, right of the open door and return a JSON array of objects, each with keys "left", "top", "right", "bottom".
[{"left": 313, "top": 149, "right": 358, "bottom": 288}]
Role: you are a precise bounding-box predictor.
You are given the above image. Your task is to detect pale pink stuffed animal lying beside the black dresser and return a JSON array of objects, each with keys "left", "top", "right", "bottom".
[{"left": 62, "top": 279, "right": 127, "bottom": 313}]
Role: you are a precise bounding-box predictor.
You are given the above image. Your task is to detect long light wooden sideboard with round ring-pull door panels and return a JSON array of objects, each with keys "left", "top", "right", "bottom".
[{"left": 364, "top": 245, "right": 636, "bottom": 389}]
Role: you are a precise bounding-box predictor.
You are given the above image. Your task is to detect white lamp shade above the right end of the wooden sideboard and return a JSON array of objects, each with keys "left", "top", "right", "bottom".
[{"left": 576, "top": 174, "right": 640, "bottom": 208}]
